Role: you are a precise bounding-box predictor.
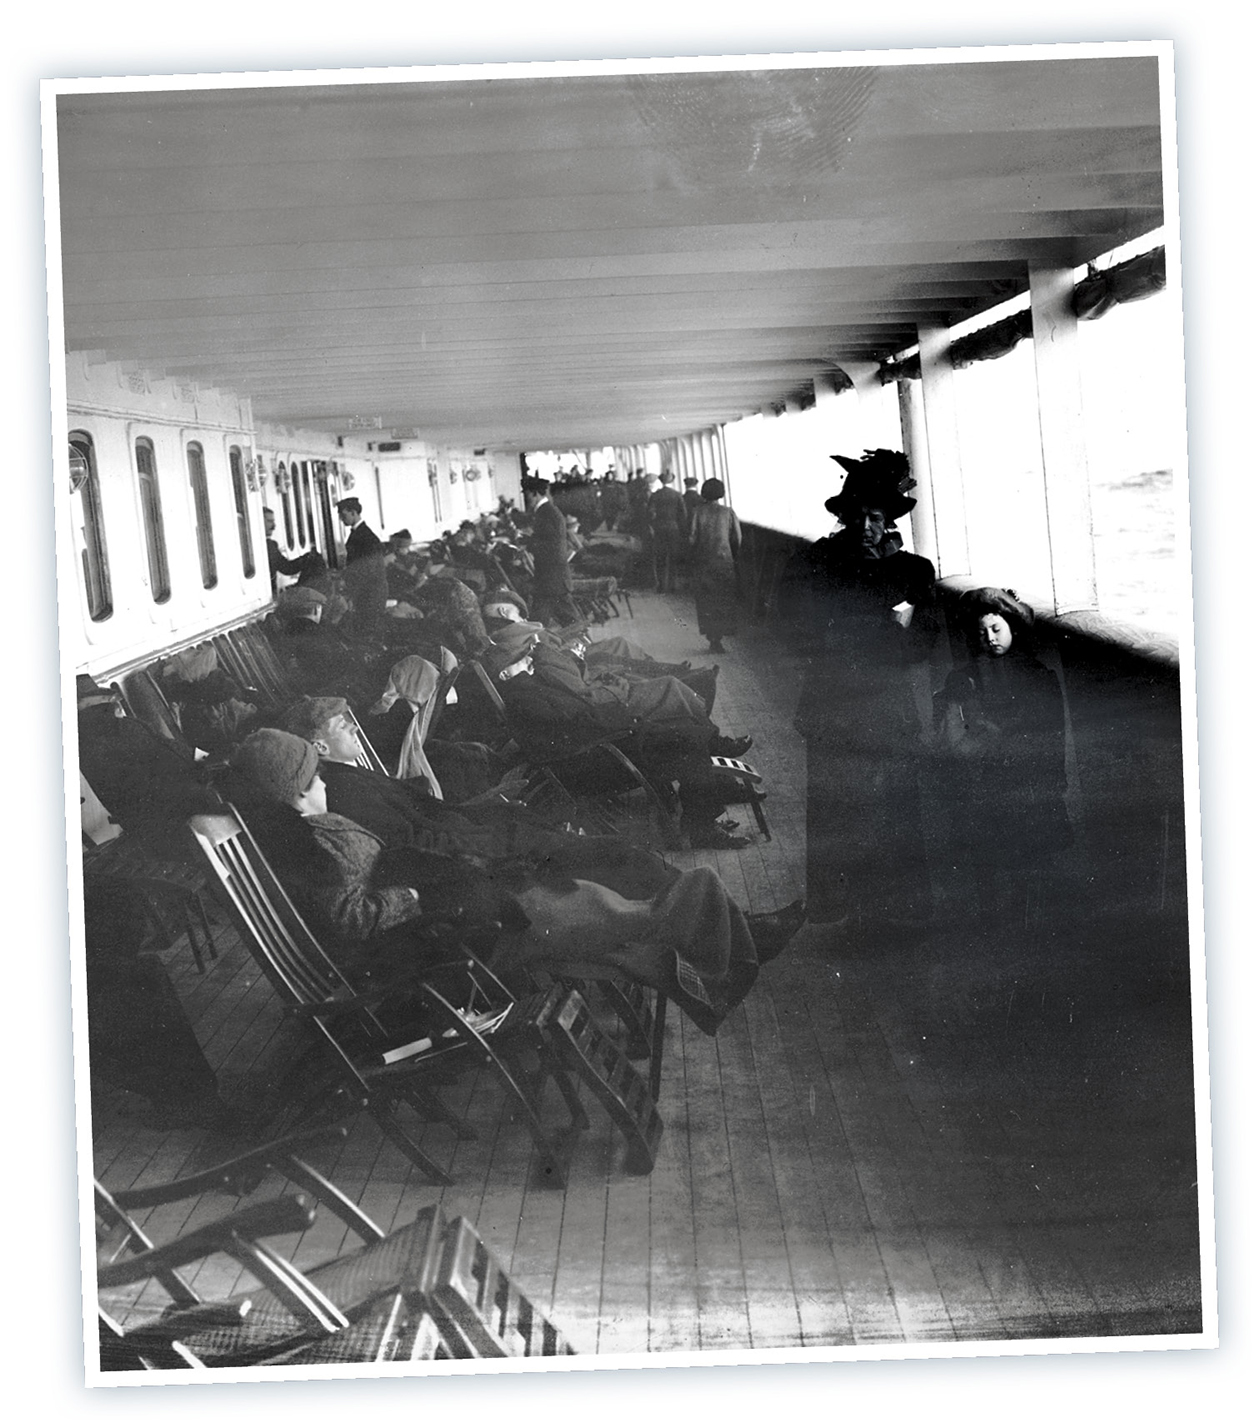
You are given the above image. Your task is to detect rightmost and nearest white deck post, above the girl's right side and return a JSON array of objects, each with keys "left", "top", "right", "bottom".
[{"left": 1028, "top": 267, "right": 1098, "bottom": 614}]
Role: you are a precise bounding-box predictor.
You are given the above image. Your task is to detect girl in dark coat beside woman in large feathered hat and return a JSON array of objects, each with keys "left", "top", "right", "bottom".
[{"left": 936, "top": 587, "right": 1072, "bottom": 875}]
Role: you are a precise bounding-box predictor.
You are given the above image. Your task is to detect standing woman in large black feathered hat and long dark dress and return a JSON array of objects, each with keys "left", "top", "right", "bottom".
[{"left": 779, "top": 450, "right": 938, "bottom": 940}]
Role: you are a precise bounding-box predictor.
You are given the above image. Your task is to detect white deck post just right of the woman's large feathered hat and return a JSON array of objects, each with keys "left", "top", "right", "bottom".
[{"left": 911, "top": 323, "right": 971, "bottom": 578}]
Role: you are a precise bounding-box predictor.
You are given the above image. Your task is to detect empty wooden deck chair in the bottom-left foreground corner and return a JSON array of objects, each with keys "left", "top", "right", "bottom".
[{"left": 96, "top": 1127, "right": 572, "bottom": 1371}]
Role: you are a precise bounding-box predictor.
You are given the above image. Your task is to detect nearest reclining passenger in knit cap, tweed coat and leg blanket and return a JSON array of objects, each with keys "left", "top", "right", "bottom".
[{"left": 233, "top": 730, "right": 804, "bottom": 1034}]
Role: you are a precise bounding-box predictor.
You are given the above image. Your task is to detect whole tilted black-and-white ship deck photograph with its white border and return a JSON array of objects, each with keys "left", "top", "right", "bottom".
[{"left": 14, "top": 8, "right": 1243, "bottom": 1412}]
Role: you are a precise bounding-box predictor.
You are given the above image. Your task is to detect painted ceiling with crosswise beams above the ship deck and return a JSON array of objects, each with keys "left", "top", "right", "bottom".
[{"left": 59, "top": 56, "right": 1163, "bottom": 450}]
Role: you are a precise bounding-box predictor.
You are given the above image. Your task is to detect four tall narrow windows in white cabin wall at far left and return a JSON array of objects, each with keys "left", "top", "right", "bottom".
[{"left": 70, "top": 431, "right": 257, "bottom": 620}]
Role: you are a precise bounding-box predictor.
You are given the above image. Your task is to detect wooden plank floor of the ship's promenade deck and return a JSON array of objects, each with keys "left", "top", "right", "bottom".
[{"left": 93, "top": 594, "right": 1202, "bottom": 1355}]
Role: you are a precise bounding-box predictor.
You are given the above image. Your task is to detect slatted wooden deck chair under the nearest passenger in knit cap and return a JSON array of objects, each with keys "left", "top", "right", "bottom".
[{"left": 190, "top": 805, "right": 588, "bottom": 1187}]
